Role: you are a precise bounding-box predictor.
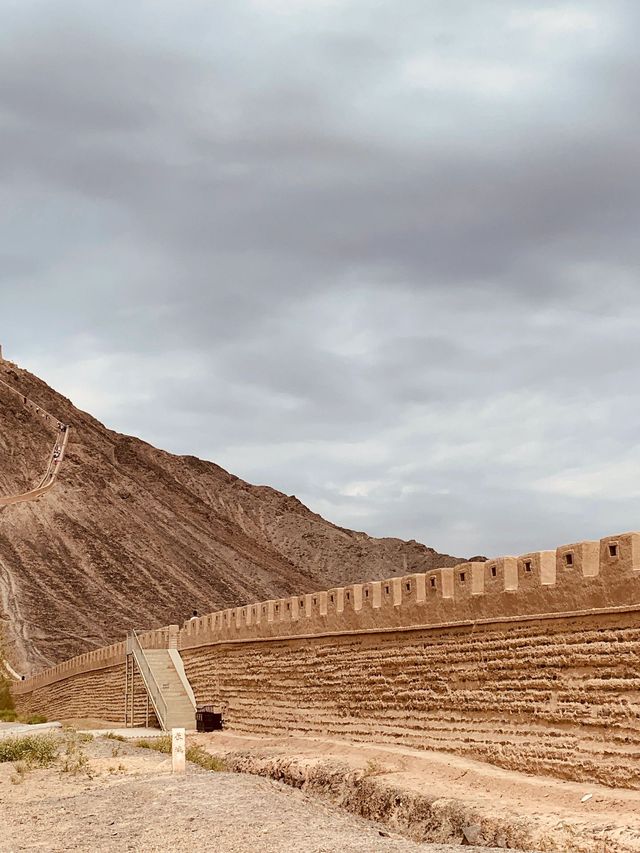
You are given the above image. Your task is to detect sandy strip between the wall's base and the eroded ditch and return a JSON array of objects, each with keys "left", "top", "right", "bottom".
[{"left": 192, "top": 732, "right": 640, "bottom": 853}]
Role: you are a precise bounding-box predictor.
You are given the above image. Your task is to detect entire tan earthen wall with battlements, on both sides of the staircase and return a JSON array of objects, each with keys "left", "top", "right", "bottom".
[{"left": 15, "top": 533, "right": 640, "bottom": 787}]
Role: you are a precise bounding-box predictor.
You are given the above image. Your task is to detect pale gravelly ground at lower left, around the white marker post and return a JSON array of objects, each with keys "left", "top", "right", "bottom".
[{"left": 0, "top": 738, "right": 516, "bottom": 853}]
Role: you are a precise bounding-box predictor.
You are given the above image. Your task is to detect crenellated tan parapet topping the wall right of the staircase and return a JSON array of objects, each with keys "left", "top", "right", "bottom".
[{"left": 179, "top": 532, "right": 640, "bottom": 648}]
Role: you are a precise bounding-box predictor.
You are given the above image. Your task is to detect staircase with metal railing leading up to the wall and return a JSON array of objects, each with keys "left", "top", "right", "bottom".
[{"left": 125, "top": 631, "right": 196, "bottom": 732}]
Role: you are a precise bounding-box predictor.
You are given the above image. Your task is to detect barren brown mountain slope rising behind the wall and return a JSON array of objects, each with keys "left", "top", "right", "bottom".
[{"left": 0, "top": 361, "right": 460, "bottom": 672}]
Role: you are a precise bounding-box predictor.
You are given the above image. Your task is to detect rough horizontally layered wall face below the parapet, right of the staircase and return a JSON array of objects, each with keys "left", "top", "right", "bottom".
[{"left": 182, "top": 611, "right": 640, "bottom": 788}]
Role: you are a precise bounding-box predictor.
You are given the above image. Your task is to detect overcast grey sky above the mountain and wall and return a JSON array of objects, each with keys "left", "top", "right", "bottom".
[{"left": 0, "top": 0, "right": 640, "bottom": 555}]
